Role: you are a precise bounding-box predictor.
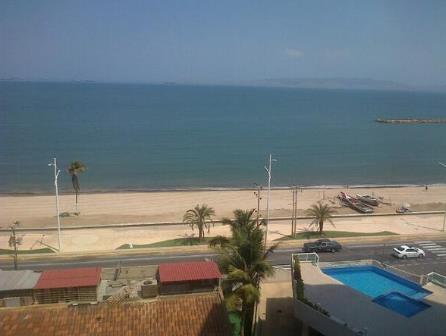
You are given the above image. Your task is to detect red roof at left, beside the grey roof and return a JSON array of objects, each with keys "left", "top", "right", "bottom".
[{"left": 34, "top": 267, "right": 102, "bottom": 289}]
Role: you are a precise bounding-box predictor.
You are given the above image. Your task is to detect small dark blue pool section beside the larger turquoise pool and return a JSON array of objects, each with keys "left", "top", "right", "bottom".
[{"left": 373, "top": 292, "right": 430, "bottom": 317}]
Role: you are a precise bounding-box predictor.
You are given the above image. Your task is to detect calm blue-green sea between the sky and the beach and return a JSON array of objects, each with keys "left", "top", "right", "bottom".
[{"left": 0, "top": 82, "right": 446, "bottom": 193}]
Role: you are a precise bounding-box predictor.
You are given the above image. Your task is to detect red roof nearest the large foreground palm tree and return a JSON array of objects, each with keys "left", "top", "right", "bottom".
[{"left": 158, "top": 261, "right": 221, "bottom": 283}]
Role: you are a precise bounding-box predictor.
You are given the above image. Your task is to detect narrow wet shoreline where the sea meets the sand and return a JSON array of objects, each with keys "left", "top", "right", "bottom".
[{"left": 0, "top": 183, "right": 446, "bottom": 197}]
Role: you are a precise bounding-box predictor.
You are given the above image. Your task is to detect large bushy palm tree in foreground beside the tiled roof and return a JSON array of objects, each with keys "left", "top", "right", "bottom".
[{"left": 210, "top": 210, "right": 277, "bottom": 336}]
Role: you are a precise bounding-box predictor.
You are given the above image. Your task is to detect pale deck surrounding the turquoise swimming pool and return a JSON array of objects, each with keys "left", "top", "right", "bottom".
[{"left": 301, "top": 263, "right": 446, "bottom": 336}]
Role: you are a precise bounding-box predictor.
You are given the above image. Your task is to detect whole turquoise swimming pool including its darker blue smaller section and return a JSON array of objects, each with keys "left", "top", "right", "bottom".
[{"left": 322, "top": 266, "right": 431, "bottom": 317}]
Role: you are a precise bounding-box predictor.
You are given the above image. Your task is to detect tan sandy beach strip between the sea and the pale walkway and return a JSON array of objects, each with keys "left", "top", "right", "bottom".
[{"left": 0, "top": 186, "right": 446, "bottom": 228}]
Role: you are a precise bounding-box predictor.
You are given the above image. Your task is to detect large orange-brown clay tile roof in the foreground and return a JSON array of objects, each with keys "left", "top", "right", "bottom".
[{"left": 0, "top": 292, "right": 230, "bottom": 336}]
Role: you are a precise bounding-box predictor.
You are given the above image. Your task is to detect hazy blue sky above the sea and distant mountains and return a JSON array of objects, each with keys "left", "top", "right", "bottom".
[{"left": 0, "top": 0, "right": 446, "bottom": 85}]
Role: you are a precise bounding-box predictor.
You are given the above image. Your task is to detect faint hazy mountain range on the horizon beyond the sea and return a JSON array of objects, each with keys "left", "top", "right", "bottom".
[{"left": 244, "top": 78, "right": 446, "bottom": 92}]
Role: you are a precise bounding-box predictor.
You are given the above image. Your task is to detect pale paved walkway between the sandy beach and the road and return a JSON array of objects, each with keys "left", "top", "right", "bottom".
[{"left": 0, "top": 215, "right": 444, "bottom": 252}]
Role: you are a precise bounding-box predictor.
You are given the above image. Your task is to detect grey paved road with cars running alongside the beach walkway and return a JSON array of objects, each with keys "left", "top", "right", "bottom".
[{"left": 0, "top": 240, "right": 446, "bottom": 274}]
